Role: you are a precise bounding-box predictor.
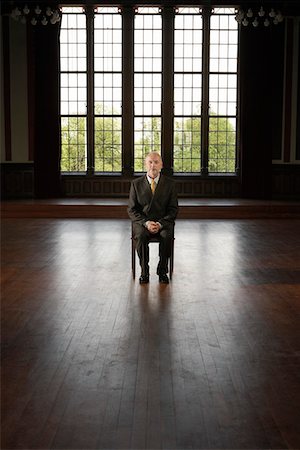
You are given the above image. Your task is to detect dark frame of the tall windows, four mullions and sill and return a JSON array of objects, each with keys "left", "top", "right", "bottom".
[{"left": 61, "top": 5, "right": 239, "bottom": 179}]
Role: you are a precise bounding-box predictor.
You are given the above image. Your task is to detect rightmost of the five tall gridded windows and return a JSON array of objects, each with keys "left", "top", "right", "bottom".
[{"left": 208, "top": 8, "right": 238, "bottom": 173}]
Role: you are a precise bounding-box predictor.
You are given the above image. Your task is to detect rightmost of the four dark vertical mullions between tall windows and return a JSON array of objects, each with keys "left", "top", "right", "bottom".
[{"left": 201, "top": 7, "right": 211, "bottom": 175}]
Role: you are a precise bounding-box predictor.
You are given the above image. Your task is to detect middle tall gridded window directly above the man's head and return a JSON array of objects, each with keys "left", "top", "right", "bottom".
[{"left": 134, "top": 8, "right": 162, "bottom": 172}]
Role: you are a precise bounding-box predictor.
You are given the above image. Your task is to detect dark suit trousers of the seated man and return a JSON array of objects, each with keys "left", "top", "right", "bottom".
[{"left": 133, "top": 223, "right": 174, "bottom": 276}]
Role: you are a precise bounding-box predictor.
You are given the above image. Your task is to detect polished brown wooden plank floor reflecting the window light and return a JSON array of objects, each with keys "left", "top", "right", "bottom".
[{"left": 1, "top": 219, "right": 300, "bottom": 450}]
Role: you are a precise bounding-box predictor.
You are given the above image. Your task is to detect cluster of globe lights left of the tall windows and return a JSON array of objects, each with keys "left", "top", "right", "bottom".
[{"left": 10, "top": 5, "right": 61, "bottom": 26}]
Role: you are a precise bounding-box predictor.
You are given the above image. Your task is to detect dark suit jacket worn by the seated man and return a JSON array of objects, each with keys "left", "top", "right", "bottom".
[{"left": 127, "top": 174, "right": 178, "bottom": 228}]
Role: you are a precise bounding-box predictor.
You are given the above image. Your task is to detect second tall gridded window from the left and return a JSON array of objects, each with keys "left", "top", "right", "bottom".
[{"left": 94, "top": 7, "right": 122, "bottom": 172}]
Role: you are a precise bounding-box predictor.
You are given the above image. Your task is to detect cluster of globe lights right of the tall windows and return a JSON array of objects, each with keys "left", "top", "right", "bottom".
[{"left": 235, "top": 6, "right": 284, "bottom": 28}]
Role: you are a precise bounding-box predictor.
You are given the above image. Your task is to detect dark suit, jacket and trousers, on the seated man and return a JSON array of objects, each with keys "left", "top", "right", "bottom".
[{"left": 128, "top": 174, "right": 178, "bottom": 275}]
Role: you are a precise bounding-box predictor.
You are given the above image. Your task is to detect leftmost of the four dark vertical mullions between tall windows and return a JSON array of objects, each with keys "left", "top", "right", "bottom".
[{"left": 86, "top": 6, "right": 95, "bottom": 176}]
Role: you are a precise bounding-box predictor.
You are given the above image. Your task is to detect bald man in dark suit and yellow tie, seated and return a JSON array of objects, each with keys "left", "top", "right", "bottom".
[{"left": 128, "top": 152, "right": 178, "bottom": 284}]
